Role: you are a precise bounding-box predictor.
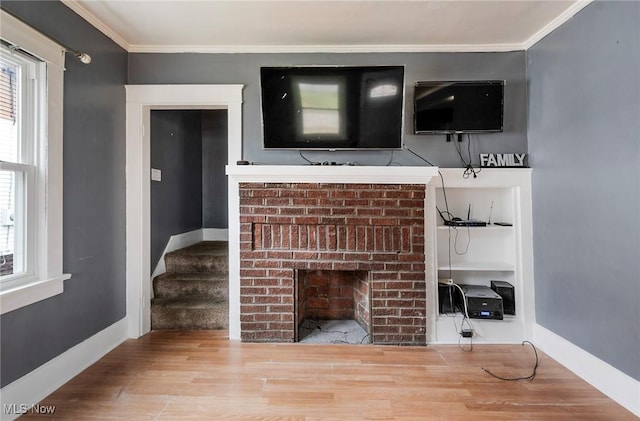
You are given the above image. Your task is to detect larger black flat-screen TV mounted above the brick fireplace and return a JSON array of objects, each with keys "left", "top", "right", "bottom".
[{"left": 260, "top": 66, "right": 404, "bottom": 150}]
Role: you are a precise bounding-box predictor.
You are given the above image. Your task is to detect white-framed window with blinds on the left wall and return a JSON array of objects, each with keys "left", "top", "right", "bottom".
[{"left": 0, "top": 11, "right": 70, "bottom": 314}]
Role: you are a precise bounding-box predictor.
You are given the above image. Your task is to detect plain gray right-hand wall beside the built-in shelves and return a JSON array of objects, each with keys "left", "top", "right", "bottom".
[{"left": 528, "top": 2, "right": 640, "bottom": 380}]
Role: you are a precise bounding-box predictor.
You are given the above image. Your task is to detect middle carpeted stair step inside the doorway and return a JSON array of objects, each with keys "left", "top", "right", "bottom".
[{"left": 153, "top": 272, "right": 229, "bottom": 300}]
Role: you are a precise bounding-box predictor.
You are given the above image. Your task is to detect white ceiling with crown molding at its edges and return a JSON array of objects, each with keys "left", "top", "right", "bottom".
[{"left": 62, "top": 0, "right": 590, "bottom": 52}]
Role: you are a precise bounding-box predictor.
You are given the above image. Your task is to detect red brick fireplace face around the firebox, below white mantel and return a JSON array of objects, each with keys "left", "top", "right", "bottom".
[{"left": 240, "top": 183, "right": 426, "bottom": 344}]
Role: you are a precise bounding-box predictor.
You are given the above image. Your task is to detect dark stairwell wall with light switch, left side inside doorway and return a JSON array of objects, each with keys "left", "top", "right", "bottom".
[{"left": 151, "top": 110, "right": 202, "bottom": 271}]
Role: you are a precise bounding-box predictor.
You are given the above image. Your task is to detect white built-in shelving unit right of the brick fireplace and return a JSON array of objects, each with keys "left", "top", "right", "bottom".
[{"left": 426, "top": 168, "right": 534, "bottom": 343}]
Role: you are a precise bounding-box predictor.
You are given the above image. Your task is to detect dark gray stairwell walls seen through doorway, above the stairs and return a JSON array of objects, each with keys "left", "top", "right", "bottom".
[{"left": 151, "top": 110, "right": 228, "bottom": 271}]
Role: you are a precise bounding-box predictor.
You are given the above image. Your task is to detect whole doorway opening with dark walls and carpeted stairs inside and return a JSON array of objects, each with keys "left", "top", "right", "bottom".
[{"left": 151, "top": 110, "right": 229, "bottom": 330}]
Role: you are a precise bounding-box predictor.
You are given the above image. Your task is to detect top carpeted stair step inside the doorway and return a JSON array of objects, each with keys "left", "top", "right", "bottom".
[{"left": 164, "top": 241, "right": 229, "bottom": 273}]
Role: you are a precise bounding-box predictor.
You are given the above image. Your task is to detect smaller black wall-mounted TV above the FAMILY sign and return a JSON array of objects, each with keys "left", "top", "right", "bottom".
[{"left": 414, "top": 80, "right": 504, "bottom": 134}]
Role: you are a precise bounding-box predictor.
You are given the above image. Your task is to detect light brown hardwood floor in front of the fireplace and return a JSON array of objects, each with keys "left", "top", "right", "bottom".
[{"left": 21, "top": 331, "right": 637, "bottom": 421}]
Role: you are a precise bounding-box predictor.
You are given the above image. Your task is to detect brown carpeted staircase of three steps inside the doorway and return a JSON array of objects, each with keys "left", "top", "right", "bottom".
[{"left": 151, "top": 241, "right": 229, "bottom": 330}]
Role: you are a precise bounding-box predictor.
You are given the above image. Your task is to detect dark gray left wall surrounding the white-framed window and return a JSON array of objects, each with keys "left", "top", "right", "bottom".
[{"left": 0, "top": 0, "right": 127, "bottom": 386}]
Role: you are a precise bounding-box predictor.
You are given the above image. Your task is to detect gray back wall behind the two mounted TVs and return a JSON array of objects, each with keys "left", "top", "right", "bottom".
[{"left": 129, "top": 51, "right": 527, "bottom": 167}]
